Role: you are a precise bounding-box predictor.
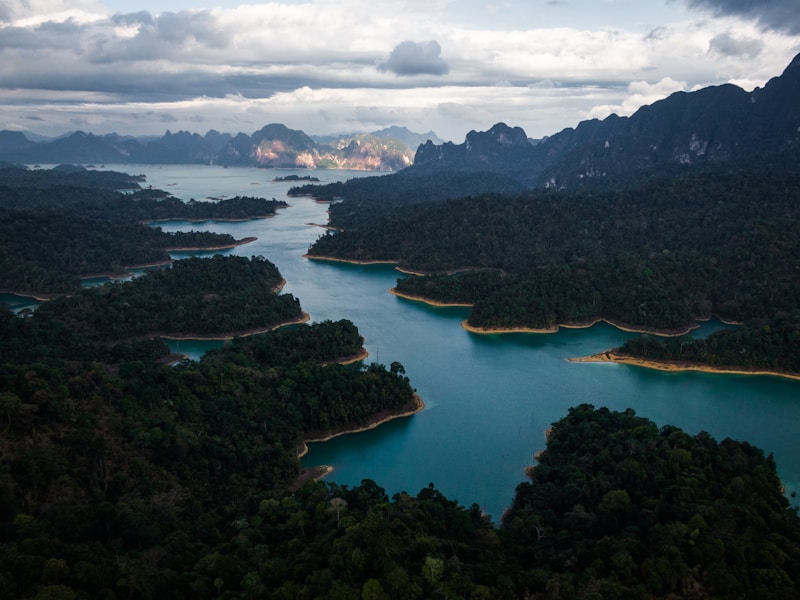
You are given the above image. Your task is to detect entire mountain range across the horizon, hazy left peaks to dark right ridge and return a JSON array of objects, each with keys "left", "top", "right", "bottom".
[{"left": 0, "top": 54, "right": 800, "bottom": 180}]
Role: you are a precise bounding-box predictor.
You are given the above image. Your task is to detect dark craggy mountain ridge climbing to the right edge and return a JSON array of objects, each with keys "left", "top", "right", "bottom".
[{"left": 411, "top": 55, "right": 800, "bottom": 187}]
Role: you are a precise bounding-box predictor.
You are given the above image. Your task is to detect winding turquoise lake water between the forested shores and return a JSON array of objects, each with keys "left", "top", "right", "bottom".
[{"left": 62, "top": 165, "right": 800, "bottom": 520}]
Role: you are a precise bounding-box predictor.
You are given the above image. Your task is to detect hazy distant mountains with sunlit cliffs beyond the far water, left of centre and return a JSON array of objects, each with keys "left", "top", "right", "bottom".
[{"left": 0, "top": 123, "right": 441, "bottom": 171}]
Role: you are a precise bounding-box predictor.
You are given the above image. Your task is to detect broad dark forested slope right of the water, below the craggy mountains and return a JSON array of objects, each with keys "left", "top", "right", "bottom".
[{"left": 309, "top": 172, "right": 800, "bottom": 340}]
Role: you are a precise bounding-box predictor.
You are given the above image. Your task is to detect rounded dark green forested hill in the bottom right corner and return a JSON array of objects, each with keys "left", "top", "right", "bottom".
[{"left": 501, "top": 405, "right": 800, "bottom": 598}]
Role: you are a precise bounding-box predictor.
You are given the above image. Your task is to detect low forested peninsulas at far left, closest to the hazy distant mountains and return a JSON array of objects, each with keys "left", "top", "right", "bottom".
[{"left": 0, "top": 166, "right": 286, "bottom": 296}]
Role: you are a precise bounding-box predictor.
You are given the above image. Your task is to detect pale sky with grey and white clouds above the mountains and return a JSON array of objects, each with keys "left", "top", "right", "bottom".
[{"left": 0, "top": 0, "right": 800, "bottom": 142}]
